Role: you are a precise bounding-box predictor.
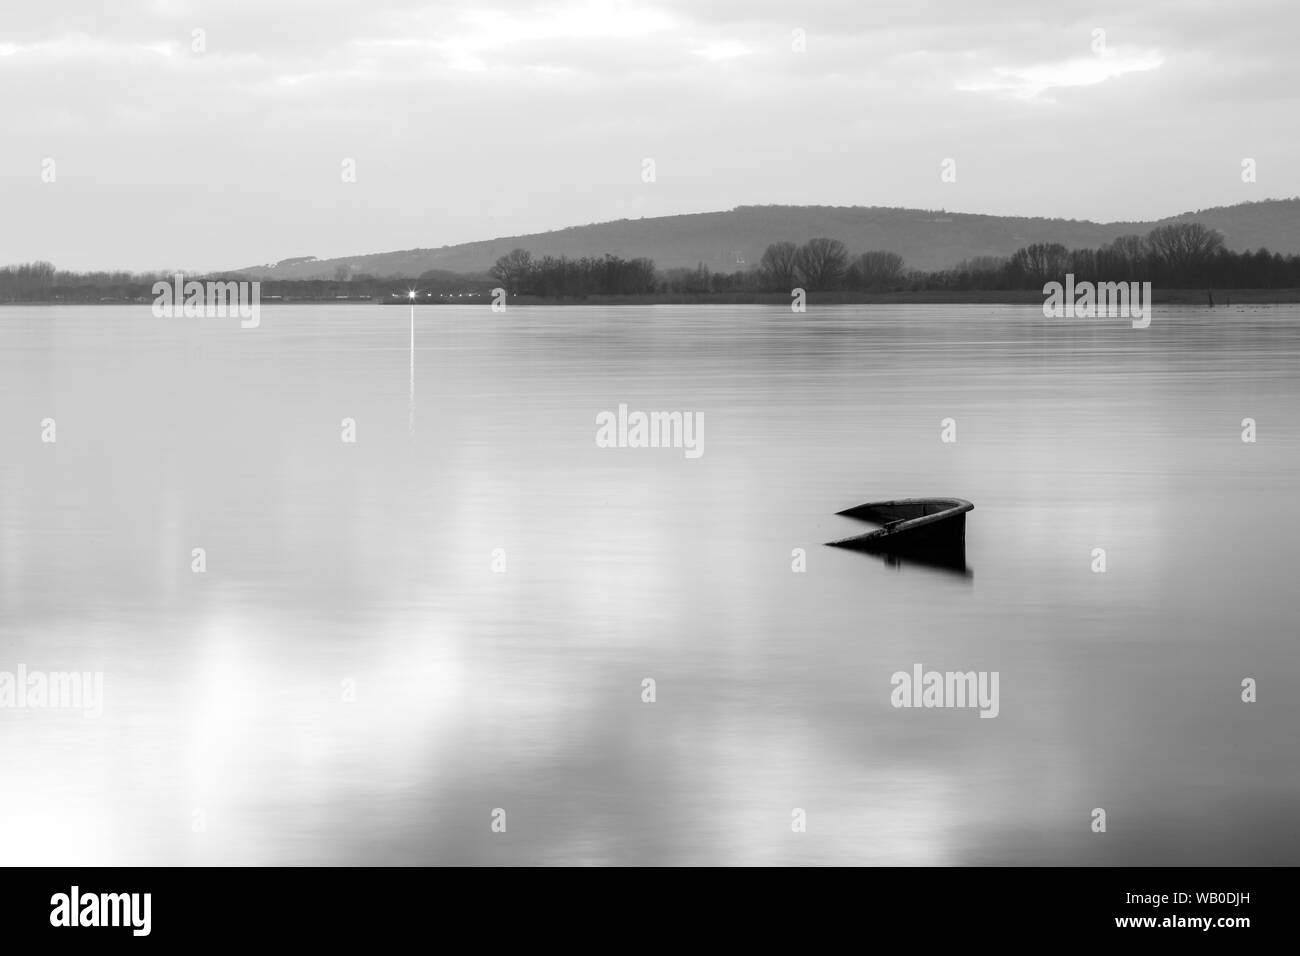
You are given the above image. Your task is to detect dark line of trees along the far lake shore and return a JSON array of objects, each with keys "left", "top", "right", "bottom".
[{"left": 15, "top": 222, "right": 1300, "bottom": 303}]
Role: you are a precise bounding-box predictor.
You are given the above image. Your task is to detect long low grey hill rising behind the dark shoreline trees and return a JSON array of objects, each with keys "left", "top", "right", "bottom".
[{"left": 233, "top": 199, "right": 1300, "bottom": 278}]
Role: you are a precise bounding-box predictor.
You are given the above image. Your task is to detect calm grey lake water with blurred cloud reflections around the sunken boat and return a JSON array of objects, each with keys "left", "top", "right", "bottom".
[{"left": 0, "top": 306, "right": 1300, "bottom": 865}]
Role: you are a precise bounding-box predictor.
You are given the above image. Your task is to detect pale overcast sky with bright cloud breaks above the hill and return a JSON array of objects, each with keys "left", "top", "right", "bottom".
[{"left": 0, "top": 0, "right": 1300, "bottom": 269}]
